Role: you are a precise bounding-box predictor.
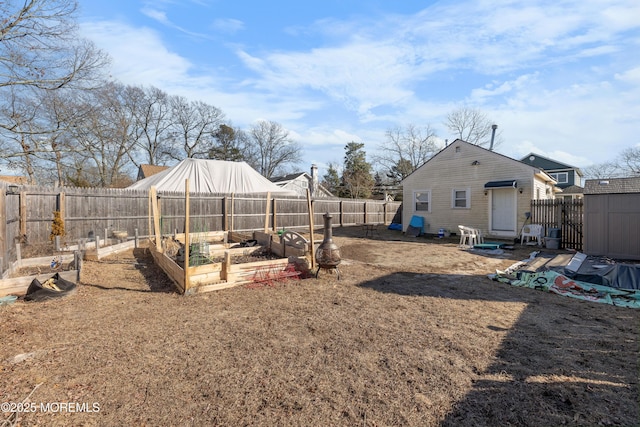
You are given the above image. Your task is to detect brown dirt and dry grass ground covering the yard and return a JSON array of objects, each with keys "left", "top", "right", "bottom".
[{"left": 0, "top": 228, "right": 640, "bottom": 426}]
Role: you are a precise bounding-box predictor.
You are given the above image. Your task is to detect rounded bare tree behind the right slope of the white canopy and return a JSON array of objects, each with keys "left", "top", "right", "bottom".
[{"left": 249, "top": 120, "right": 302, "bottom": 178}]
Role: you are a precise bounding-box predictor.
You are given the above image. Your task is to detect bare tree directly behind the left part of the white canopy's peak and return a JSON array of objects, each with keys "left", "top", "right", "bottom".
[{"left": 171, "top": 96, "right": 224, "bottom": 160}]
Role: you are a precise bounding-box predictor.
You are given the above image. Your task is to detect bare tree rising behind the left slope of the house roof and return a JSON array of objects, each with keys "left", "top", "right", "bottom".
[{"left": 373, "top": 124, "right": 440, "bottom": 182}]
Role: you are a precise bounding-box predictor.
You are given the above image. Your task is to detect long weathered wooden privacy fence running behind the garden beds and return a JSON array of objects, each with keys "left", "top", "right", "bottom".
[{"left": 0, "top": 183, "right": 401, "bottom": 271}]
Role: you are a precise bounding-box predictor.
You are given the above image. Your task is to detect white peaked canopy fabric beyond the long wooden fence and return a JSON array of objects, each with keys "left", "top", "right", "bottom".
[{"left": 127, "top": 159, "right": 296, "bottom": 196}]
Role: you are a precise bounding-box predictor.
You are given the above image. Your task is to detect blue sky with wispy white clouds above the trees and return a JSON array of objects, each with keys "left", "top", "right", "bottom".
[{"left": 80, "top": 0, "right": 640, "bottom": 174}]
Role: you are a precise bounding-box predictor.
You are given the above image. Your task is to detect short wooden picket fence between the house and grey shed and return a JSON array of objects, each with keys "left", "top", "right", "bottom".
[{"left": 531, "top": 199, "right": 584, "bottom": 251}]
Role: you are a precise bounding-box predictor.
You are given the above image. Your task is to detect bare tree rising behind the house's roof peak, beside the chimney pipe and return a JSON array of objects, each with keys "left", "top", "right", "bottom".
[{"left": 445, "top": 107, "right": 501, "bottom": 148}]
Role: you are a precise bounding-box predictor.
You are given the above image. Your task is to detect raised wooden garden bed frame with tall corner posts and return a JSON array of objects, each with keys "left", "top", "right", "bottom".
[{"left": 149, "top": 179, "right": 315, "bottom": 295}]
